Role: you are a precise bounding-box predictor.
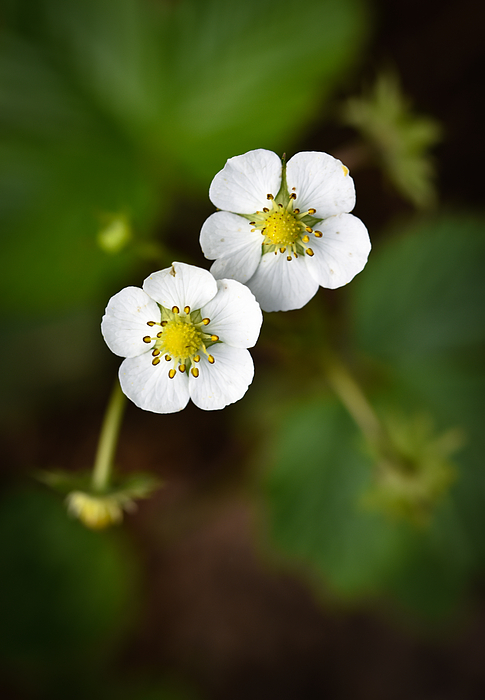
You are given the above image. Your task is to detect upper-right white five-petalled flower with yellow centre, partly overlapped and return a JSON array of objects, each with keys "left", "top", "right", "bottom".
[{"left": 200, "top": 149, "right": 371, "bottom": 311}]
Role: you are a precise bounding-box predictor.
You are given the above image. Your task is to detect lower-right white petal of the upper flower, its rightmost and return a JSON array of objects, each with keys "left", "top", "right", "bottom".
[{"left": 306, "top": 214, "right": 371, "bottom": 289}]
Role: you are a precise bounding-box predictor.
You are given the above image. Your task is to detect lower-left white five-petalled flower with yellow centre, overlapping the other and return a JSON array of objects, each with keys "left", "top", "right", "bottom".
[{"left": 101, "top": 262, "right": 262, "bottom": 413}]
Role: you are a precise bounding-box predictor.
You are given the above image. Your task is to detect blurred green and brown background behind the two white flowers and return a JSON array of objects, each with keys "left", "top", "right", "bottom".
[{"left": 0, "top": 0, "right": 485, "bottom": 700}]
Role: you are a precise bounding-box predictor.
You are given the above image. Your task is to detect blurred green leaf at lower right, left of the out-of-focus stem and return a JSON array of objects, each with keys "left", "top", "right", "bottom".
[{"left": 263, "top": 399, "right": 406, "bottom": 597}]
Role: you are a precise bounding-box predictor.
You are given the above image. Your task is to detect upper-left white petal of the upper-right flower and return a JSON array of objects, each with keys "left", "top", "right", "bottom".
[{"left": 209, "top": 148, "right": 282, "bottom": 214}]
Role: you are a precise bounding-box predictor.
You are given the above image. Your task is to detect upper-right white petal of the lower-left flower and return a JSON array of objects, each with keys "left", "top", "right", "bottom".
[{"left": 201, "top": 280, "right": 263, "bottom": 348}]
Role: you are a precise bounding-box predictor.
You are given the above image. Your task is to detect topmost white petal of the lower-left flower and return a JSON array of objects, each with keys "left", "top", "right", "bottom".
[{"left": 143, "top": 262, "right": 217, "bottom": 311}]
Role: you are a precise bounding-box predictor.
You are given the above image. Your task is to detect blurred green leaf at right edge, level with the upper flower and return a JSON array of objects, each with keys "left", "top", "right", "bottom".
[{"left": 351, "top": 214, "right": 485, "bottom": 364}]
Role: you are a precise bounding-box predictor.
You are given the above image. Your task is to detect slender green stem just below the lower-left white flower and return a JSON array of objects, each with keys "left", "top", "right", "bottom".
[{"left": 92, "top": 380, "right": 126, "bottom": 491}]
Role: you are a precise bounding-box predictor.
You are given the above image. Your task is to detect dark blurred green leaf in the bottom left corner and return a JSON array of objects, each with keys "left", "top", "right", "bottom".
[{"left": 0, "top": 489, "right": 134, "bottom": 683}]
